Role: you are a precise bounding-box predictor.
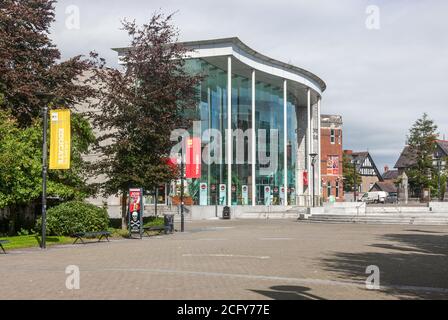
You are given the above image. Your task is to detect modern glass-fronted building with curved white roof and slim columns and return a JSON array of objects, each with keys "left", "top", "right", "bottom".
[{"left": 118, "top": 38, "right": 326, "bottom": 206}]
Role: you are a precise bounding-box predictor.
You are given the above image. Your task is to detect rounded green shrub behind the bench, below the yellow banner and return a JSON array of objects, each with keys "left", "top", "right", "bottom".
[{"left": 36, "top": 201, "right": 109, "bottom": 236}]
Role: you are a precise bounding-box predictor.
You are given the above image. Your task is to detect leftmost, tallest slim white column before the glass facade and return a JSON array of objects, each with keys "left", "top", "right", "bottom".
[{"left": 227, "top": 56, "right": 233, "bottom": 206}]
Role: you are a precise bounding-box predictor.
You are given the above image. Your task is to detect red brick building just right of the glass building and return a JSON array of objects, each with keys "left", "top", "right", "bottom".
[{"left": 321, "top": 115, "right": 344, "bottom": 202}]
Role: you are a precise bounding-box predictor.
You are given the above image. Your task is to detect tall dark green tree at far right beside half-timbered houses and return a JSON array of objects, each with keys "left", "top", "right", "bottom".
[{"left": 406, "top": 113, "right": 438, "bottom": 198}]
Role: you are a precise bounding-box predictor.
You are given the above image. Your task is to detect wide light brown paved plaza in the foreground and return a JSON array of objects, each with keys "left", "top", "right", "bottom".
[{"left": 0, "top": 220, "right": 448, "bottom": 300}]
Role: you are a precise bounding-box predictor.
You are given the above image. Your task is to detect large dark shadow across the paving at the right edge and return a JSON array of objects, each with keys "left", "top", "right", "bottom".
[{"left": 322, "top": 230, "right": 448, "bottom": 299}]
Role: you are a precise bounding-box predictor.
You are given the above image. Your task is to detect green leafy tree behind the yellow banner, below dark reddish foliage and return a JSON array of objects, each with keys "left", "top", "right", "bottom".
[{"left": 0, "top": 110, "right": 95, "bottom": 232}]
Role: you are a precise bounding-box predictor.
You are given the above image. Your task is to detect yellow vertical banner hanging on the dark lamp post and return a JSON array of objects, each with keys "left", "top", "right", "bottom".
[{"left": 50, "top": 110, "right": 71, "bottom": 170}]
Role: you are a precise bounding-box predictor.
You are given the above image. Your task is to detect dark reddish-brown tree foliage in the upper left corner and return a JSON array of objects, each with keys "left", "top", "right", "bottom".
[{"left": 0, "top": 0, "right": 97, "bottom": 126}]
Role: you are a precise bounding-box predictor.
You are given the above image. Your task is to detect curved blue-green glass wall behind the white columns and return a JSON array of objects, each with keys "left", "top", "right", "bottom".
[{"left": 182, "top": 59, "right": 304, "bottom": 205}]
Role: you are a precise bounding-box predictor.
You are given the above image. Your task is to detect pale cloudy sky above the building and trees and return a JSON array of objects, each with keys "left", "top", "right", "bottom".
[{"left": 51, "top": 0, "right": 448, "bottom": 171}]
